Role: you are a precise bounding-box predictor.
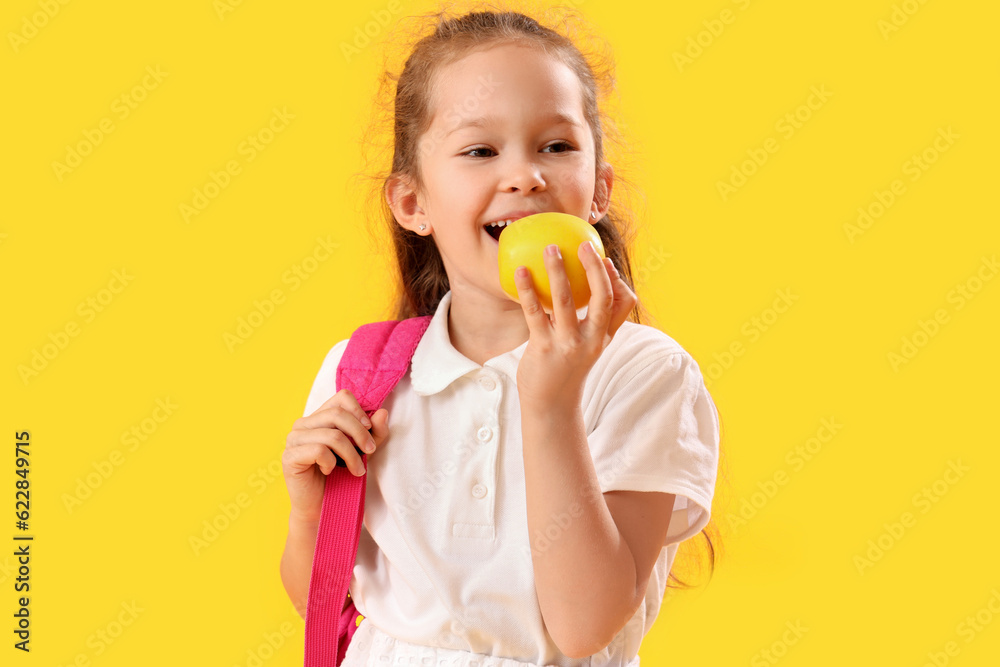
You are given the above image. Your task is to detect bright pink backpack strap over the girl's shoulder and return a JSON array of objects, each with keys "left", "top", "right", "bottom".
[{"left": 305, "top": 315, "right": 432, "bottom": 667}]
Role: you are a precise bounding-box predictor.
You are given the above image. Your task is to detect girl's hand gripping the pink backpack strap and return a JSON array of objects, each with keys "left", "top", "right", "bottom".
[{"left": 281, "top": 389, "right": 389, "bottom": 523}]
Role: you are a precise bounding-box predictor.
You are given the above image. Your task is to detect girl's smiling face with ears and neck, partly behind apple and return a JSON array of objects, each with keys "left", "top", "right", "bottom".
[{"left": 397, "top": 44, "right": 612, "bottom": 306}]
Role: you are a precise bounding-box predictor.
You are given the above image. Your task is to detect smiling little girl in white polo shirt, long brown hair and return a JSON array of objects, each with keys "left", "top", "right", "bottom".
[{"left": 281, "top": 6, "right": 719, "bottom": 667}]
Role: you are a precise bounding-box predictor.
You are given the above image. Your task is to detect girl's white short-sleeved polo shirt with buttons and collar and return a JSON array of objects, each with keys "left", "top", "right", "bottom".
[{"left": 304, "top": 291, "right": 719, "bottom": 667}]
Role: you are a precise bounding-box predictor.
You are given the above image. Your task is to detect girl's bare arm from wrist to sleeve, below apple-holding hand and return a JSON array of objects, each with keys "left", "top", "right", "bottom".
[{"left": 521, "top": 401, "right": 674, "bottom": 658}]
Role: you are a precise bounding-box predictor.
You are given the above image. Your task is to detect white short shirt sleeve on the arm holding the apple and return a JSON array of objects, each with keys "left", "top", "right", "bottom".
[{"left": 588, "top": 348, "right": 719, "bottom": 546}]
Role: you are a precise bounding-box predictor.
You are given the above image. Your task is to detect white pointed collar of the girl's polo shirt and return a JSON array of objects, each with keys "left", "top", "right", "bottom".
[{"left": 410, "top": 290, "right": 528, "bottom": 396}]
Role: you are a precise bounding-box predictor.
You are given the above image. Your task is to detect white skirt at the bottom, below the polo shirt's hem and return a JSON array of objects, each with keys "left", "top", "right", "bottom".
[{"left": 340, "top": 618, "right": 639, "bottom": 667}]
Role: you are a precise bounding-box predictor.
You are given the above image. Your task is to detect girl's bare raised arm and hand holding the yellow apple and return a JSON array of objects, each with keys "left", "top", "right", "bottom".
[{"left": 515, "top": 242, "right": 674, "bottom": 658}]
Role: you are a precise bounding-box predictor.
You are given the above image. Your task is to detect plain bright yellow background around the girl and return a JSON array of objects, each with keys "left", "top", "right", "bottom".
[{"left": 0, "top": 0, "right": 1000, "bottom": 667}]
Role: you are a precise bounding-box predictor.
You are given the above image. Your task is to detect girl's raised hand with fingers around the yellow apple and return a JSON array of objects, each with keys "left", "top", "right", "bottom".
[{"left": 514, "top": 241, "right": 639, "bottom": 408}]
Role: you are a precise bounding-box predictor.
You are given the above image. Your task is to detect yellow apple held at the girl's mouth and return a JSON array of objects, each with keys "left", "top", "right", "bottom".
[{"left": 499, "top": 213, "right": 604, "bottom": 313}]
